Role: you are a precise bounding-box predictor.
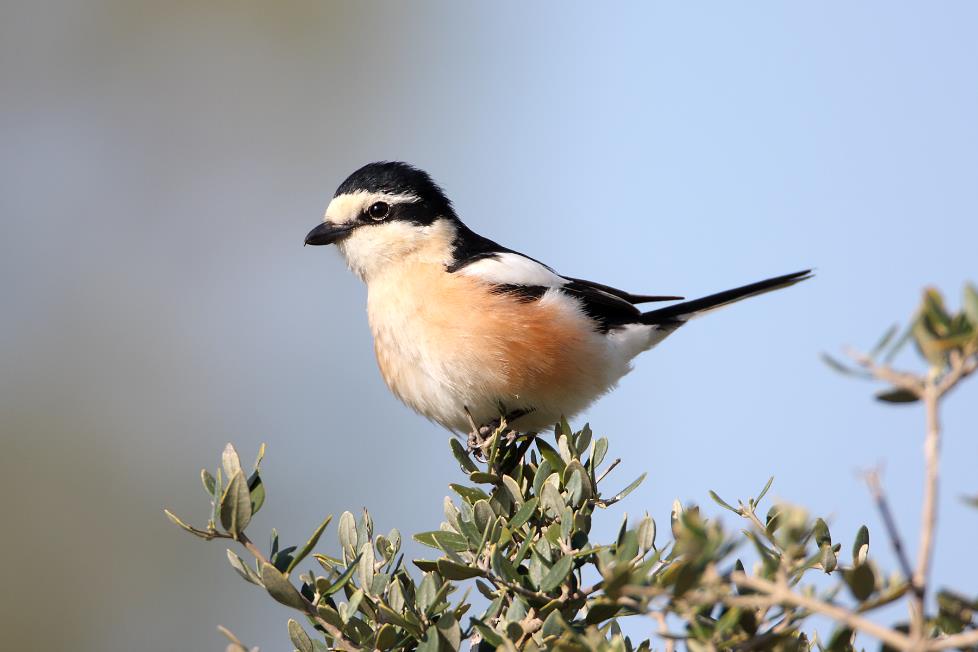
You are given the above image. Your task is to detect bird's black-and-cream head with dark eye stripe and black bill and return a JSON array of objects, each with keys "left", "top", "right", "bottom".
[{"left": 306, "top": 162, "right": 457, "bottom": 280}]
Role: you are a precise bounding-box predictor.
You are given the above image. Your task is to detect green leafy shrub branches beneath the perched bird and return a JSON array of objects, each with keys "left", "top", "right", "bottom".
[{"left": 166, "top": 288, "right": 978, "bottom": 652}]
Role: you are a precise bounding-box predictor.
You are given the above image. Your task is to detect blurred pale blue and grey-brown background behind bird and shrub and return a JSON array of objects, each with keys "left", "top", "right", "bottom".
[{"left": 0, "top": 0, "right": 978, "bottom": 651}]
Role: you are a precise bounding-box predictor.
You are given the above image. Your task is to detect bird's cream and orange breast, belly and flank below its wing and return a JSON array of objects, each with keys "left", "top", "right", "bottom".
[{"left": 368, "top": 265, "right": 654, "bottom": 432}]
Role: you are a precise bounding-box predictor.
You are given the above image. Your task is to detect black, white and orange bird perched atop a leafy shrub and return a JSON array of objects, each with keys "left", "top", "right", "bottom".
[{"left": 305, "top": 161, "right": 811, "bottom": 441}]
